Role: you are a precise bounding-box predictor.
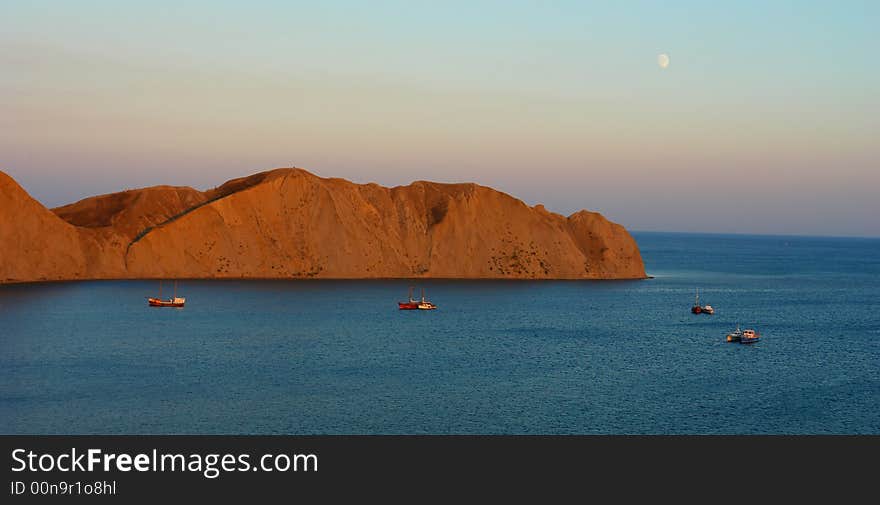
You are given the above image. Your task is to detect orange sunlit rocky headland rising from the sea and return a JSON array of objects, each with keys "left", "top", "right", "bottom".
[{"left": 0, "top": 169, "right": 645, "bottom": 282}]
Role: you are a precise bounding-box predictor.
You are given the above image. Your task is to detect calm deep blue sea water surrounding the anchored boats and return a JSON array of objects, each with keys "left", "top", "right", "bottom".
[{"left": 0, "top": 233, "right": 880, "bottom": 434}]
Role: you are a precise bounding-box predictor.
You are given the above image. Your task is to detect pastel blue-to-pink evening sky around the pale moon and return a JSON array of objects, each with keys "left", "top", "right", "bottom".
[{"left": 0, "top": 0, "right": 880, "bottom": 236}]
